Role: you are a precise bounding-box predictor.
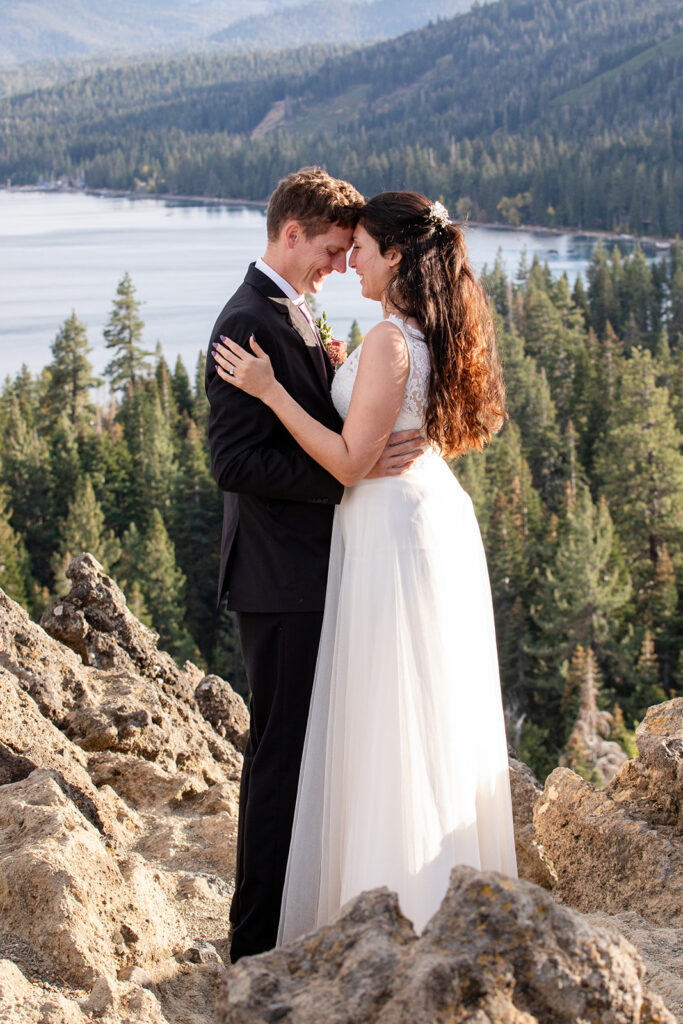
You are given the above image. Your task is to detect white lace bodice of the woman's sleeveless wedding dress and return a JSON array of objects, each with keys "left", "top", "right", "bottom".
[{"left": 332, "top": 313, "right": 430, "bottom": 430}]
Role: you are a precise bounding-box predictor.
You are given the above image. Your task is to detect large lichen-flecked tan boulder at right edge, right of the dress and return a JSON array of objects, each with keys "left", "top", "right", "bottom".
[{"left": 533, "top": 698, "right": 683, "bottom": 925}]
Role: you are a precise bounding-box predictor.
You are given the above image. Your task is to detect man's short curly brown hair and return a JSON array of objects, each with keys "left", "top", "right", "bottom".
[{"left": 266, "top": 167, "right": 365, "bottom": 242}]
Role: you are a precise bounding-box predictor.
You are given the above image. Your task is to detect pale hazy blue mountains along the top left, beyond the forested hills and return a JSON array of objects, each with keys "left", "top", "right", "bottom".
[{"left": 0, "top": 0, "right": 472, "bottom": 68}]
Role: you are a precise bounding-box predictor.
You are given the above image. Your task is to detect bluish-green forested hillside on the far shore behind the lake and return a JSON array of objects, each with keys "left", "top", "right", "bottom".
[{"left": 0, "top": 0, "right": 683, "bottom": 238}]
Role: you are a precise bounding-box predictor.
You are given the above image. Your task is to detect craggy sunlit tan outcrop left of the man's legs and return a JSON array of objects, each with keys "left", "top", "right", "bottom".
[{"left": 0, "top": 555, "right": 247, "bottom": 1024}]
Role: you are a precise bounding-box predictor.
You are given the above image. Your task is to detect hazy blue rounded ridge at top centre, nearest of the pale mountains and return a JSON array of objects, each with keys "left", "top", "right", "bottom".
[{"left": 213, "top": 0, "right": 472, "bottom": 49}]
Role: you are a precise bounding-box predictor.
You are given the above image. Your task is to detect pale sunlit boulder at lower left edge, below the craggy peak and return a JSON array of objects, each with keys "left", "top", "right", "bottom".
[{"left": 0, "top": 770, "right": 187, "bottom": 985}]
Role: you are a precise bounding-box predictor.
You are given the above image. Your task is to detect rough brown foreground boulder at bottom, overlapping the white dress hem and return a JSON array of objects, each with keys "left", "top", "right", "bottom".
[{"left": 219, "top": 867, "right": 675, "bottom": 1024}]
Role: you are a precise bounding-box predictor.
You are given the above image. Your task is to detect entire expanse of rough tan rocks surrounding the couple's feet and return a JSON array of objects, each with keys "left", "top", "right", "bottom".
[{"left": 0, "top": 555, "right": 683, "bottom": 1024}]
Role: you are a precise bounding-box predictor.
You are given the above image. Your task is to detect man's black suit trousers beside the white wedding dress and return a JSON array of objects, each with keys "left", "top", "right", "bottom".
[{"left": 230, "top": 611, "right": 323, "bottom": 963}]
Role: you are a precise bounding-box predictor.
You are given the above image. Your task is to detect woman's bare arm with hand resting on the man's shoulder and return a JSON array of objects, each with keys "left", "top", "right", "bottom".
[{"left": 214, "top": 321, "right": 410, "bottom": 486}]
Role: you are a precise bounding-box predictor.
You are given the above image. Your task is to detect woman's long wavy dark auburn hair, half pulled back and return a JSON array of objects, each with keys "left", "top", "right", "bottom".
[{"left": 359, "top": 191, "right": 506, "bottom": 456}]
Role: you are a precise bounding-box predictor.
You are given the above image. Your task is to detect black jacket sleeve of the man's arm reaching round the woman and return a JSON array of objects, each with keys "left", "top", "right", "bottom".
[{"left": 206, "top": 313, "right": 344, "bottom": 505}]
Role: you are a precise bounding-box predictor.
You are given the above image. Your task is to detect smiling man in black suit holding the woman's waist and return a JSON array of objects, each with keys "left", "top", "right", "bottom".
[{"left": 206, "top": 168, "right": 419, "bottom": 963}]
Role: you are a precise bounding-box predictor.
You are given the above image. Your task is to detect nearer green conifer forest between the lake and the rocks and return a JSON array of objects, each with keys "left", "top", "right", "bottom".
[{"left": 0, "top": 239, "right": 683, "bottom": 776}]
